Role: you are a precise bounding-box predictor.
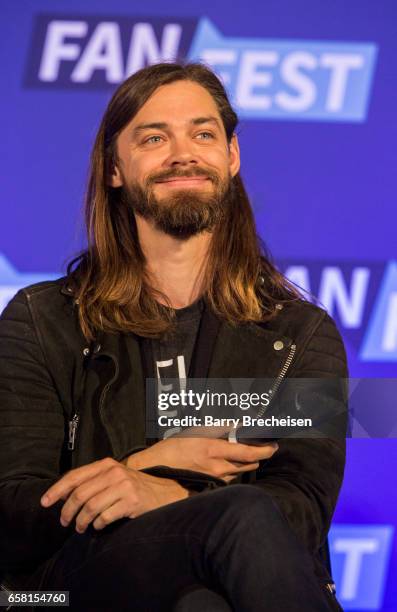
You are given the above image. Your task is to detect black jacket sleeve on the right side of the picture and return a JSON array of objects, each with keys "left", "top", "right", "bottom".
[{"left": 252, "top": 314, "right": 348, "bottom": 553}]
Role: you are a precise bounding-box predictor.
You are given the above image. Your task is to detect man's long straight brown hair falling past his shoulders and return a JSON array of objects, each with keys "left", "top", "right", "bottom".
[{"left": 68, "top": 63, "right": 302, "bottom": 340}]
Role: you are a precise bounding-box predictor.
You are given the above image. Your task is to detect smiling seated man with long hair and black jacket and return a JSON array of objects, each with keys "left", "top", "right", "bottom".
[{"left": 0, "top": 63, "right": 347, "bottom": 612}]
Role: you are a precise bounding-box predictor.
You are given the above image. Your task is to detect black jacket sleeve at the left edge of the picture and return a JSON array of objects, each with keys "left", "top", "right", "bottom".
[{"left": 0, "top": 291, "right": 73, "bottom": 572}]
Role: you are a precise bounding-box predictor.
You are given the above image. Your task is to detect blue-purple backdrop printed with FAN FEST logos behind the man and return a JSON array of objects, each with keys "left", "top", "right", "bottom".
[{"left": 0, "top": 0, "right": 397, "bottom": 612}]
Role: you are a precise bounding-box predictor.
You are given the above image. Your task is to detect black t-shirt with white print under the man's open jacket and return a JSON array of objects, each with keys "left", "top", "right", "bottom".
[{"left": 142, "top": 298, "right": 204, "bottom": 438}]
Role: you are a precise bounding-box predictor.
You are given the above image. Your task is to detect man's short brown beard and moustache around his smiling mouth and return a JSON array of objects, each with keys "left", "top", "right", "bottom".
[{"left": 121, "top": 168, "right": 232, "bottom": 240}]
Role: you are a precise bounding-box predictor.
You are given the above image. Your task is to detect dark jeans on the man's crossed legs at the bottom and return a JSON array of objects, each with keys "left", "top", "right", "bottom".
[{"left": 41, "top": 484, "right": 338, "bottom": 612}]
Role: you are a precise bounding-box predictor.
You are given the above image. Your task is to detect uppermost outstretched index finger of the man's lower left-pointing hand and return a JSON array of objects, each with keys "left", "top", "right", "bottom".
[{"left": 40, "top": 457, "right": 117, "bottom": 507}]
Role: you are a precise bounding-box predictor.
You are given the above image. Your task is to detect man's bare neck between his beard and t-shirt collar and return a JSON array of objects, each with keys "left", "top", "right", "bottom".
[{"left": 136, "top": 215, "right": 211, "bottom": 308}]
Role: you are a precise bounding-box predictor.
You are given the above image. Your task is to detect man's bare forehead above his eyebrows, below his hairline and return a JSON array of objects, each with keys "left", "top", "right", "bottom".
[{"left": 129, "top": 81, "right": 222, "bottom": 127}]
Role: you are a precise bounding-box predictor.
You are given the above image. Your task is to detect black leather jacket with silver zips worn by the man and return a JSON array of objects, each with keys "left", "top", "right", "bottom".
[{"left": 0, "top": 279, "right": 347, "bottom": 580}]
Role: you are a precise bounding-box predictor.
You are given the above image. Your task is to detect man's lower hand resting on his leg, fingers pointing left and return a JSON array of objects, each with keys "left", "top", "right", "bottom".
[{"left": 41, "top": 457, "right": 189, "bottom": 533}]
